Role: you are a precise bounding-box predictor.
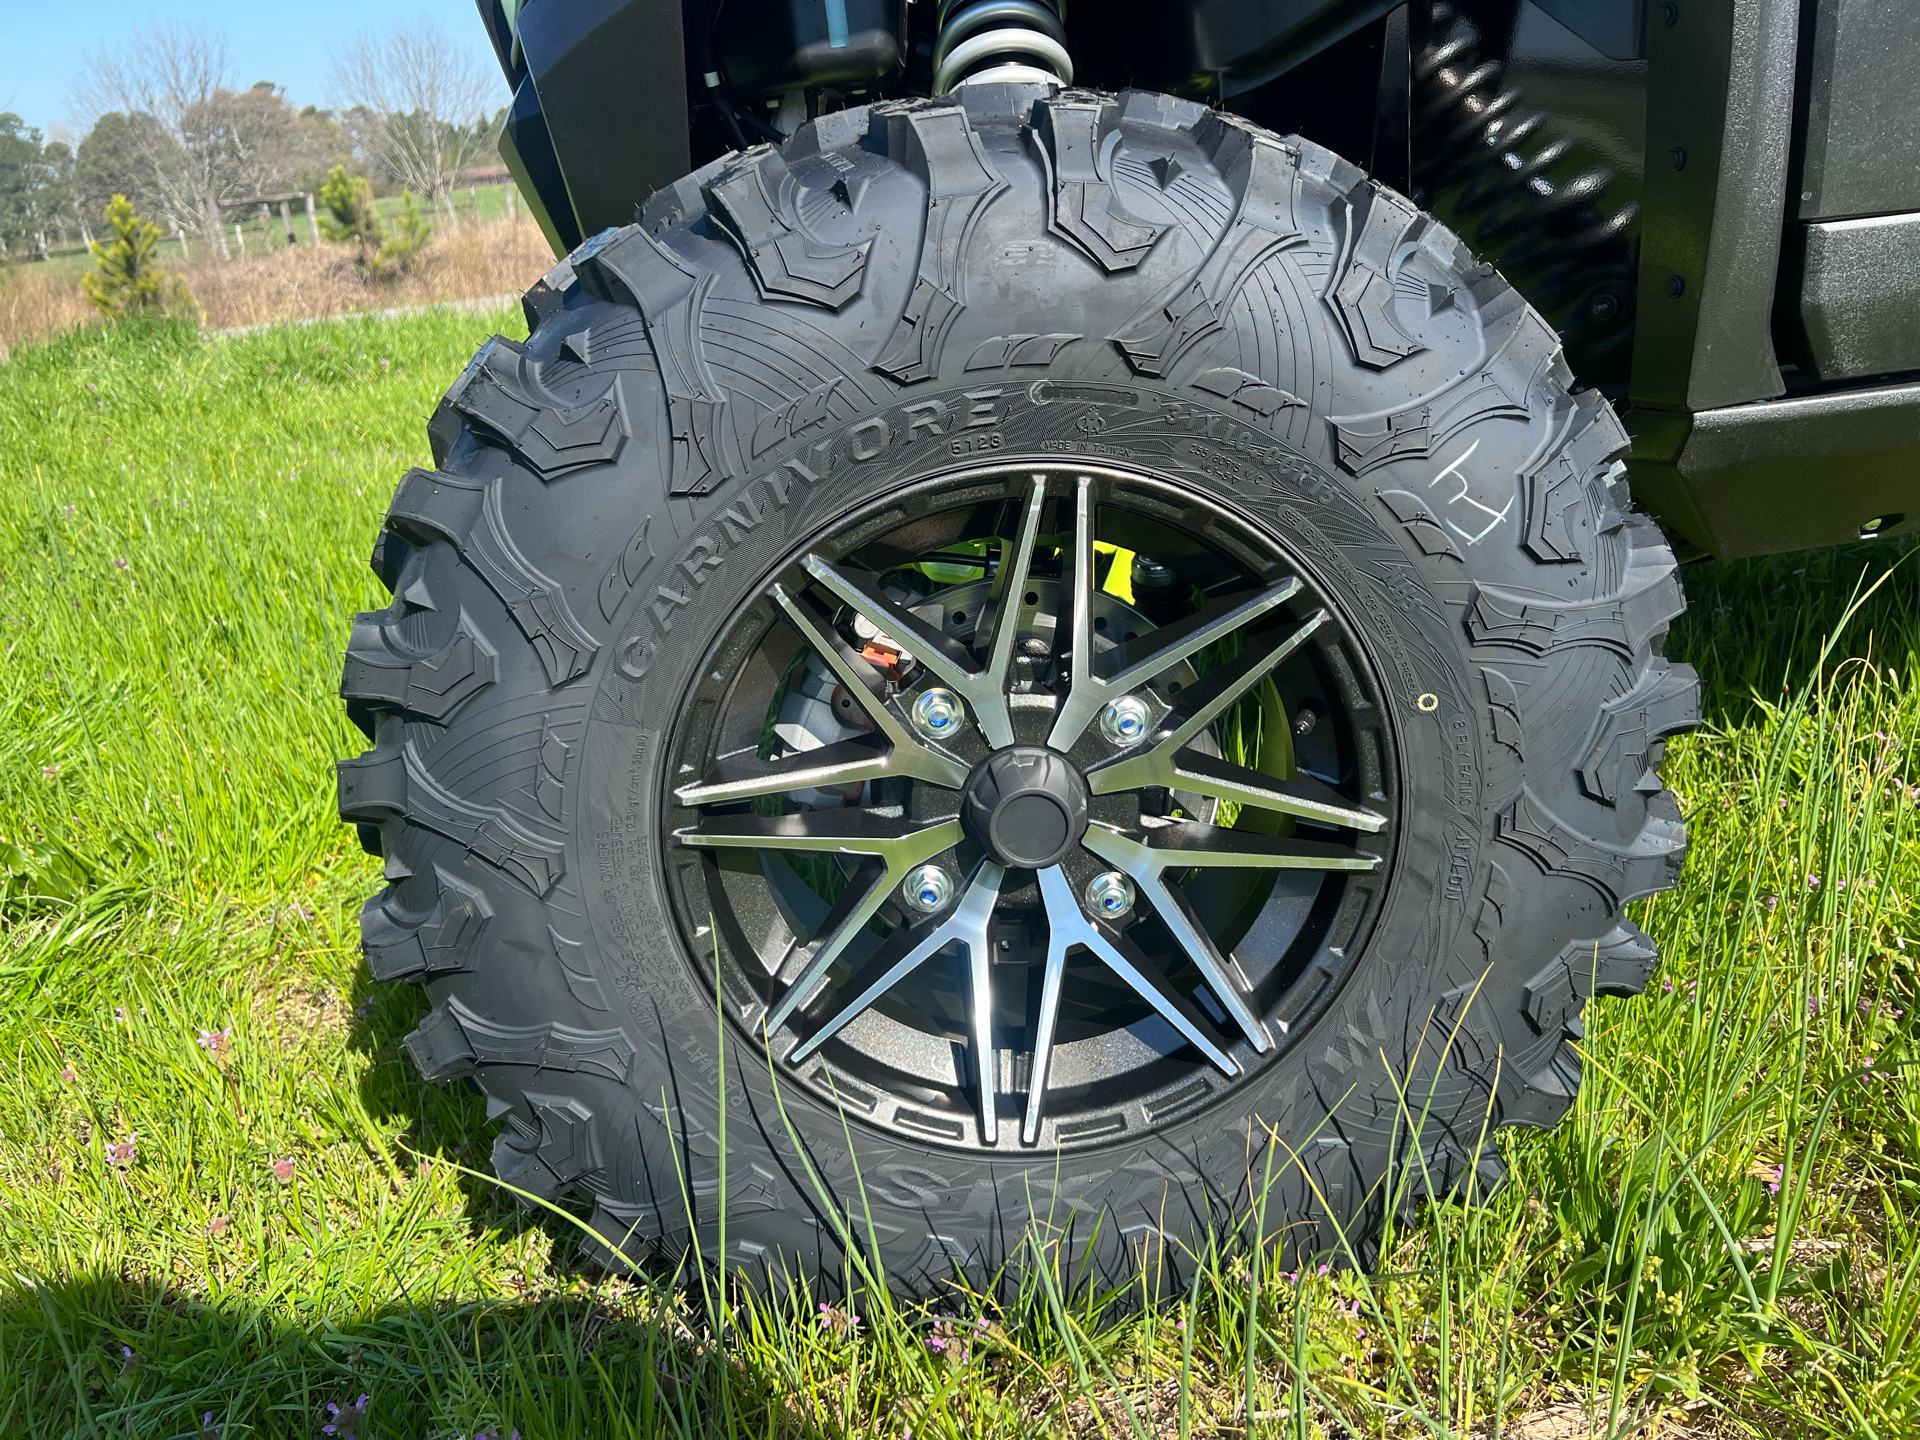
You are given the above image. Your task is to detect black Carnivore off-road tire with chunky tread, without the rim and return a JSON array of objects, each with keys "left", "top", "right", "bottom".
[{"left": 338, "top": 86, "right": 1697, "bottom": 1286}]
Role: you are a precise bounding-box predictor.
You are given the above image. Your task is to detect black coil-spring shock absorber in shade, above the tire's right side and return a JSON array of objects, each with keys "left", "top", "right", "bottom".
[{"left": 1413, "top": 0, "right": 1640, "bottom": 386}]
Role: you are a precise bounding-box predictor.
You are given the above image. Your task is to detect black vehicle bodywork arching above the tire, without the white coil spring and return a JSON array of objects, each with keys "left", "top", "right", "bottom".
[{"left": 478, "top": 0, "right": 1920, "bottom": 557}]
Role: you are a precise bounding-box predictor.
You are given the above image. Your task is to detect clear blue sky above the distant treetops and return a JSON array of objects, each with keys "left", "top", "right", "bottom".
[{"left": 0, "top": 0, "right": 507, "bottom": 131}]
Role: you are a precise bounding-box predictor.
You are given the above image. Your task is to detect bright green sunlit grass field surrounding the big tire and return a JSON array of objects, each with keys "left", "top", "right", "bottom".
[{"left": 0, "top": 315, "right": 1920, "bottom": 1440}]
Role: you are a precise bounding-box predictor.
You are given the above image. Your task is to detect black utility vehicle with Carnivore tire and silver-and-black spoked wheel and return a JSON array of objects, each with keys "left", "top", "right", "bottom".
[{"left": 340, "top": 0, "right": 1920, "bottom": 1288}]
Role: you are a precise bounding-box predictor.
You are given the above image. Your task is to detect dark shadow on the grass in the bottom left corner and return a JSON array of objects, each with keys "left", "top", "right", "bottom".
[{"left": 0, "top": 1273, "right": 826, "bottom": 1440}]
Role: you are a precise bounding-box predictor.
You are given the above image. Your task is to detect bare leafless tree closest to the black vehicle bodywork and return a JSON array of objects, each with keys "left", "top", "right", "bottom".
[{"left": 332, "top": 21, "right": 499, "bottom": 219}]
